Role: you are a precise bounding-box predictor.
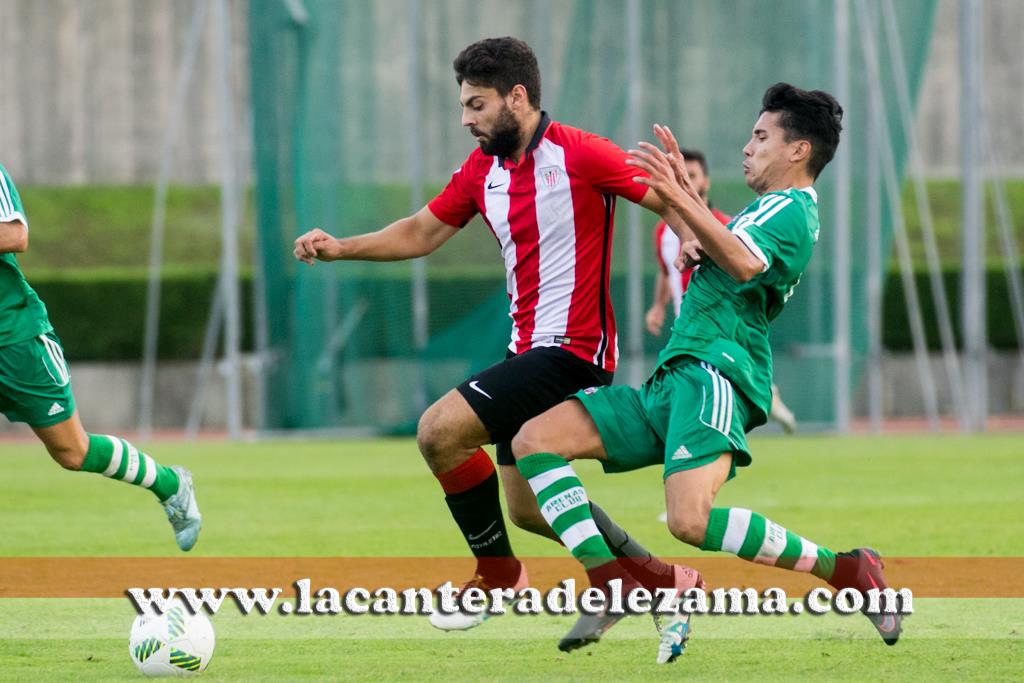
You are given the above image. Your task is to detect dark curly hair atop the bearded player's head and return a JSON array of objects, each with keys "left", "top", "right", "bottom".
[{"left": 452, "top": 37, "right": 541, "bottom": 110}]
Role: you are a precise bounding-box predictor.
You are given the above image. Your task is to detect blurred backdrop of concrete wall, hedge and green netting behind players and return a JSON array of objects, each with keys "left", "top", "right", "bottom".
[{"left": 0, "top": 0, "right": 1024, "bottom": 437}]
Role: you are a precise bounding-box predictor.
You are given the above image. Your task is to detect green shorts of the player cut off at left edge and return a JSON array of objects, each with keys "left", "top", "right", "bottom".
[{"left": 0, "top": 332, "right": 75, "bottom": 427}]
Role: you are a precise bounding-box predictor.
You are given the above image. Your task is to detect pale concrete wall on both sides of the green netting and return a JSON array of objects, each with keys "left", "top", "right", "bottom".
[{"left": 0, "top": 0, "right": 1024, "bottom": 184}]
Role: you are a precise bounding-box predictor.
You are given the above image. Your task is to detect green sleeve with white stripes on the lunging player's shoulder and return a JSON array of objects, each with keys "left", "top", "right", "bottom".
[{"left": 732, "top": 195, "right": 811, "bottom": 272}]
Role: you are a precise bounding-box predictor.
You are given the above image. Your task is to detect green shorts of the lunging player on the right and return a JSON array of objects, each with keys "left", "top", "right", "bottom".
[{"left": 574, "top": 358, "right": 752, "bottom": 479}]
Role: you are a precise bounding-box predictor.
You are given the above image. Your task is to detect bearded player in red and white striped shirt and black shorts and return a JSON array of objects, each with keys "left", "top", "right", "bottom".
[{"left": 295, "top": 38, "right": 699, "bottom": 630}]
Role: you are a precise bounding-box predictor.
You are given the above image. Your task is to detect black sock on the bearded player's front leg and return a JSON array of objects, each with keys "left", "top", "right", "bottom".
[{"left": 444, "top": 472, "right": 520, "bottom": 587}]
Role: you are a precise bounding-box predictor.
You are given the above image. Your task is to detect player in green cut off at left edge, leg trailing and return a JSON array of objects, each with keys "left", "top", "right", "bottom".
[{"left": 0, "top": 166, "right": 202, "bottom": 550}]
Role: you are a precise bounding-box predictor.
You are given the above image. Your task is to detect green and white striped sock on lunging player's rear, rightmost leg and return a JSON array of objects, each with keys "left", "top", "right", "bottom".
[{"left": 700, "top": 508, "right": 836, "bottom": 581}]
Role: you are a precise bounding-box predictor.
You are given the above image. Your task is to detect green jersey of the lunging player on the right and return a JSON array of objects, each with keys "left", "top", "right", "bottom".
[{"left": 658, "top": 187, "right": 818, "bottom": 429}]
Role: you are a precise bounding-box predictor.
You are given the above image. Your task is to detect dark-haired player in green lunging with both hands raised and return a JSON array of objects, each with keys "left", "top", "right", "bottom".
[{"left": 512, "top": 83, "right": 900, "bottom": 663}]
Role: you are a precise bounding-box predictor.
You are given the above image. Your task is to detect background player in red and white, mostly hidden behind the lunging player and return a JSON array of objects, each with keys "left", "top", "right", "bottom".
[{"left": 644, "top": 150, "right": 797, "bottom": 436}]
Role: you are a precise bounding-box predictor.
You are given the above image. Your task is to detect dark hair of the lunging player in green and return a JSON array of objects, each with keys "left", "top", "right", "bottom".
[{"left": 761, "top": 83, "right": 843, "bottom": 178}]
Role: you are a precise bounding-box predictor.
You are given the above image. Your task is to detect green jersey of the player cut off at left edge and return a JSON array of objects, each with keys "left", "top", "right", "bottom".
[{"left": 0, "top": 166, "right": 53, "bottom": 346}]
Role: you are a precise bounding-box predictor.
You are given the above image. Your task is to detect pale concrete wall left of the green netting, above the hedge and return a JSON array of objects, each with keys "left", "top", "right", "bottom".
[{"left": 0, "top": 0, "right": 249, "bottom": 184}]
